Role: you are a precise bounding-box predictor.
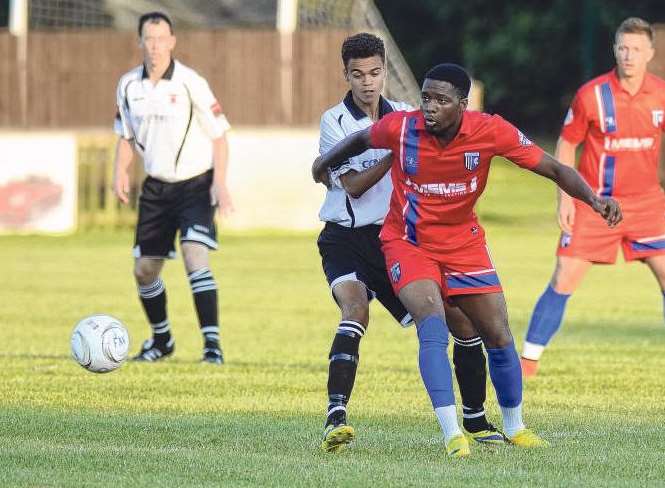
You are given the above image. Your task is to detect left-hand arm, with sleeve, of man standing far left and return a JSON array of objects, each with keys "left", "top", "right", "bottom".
[{"left": 113, "top": 78, "right": 134, "bottom": 204}]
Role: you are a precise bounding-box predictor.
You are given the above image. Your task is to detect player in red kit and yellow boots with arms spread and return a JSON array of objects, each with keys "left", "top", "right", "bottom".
[{"left": 312, "top": 64, "right": 621, "bottom": 457}]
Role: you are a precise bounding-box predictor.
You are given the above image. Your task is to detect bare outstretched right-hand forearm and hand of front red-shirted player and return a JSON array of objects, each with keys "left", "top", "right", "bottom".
[{"left": 531, "top": 153, "right": 622, "bottom": 227}]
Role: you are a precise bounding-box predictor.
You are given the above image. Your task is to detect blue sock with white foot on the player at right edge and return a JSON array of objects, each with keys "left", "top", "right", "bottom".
[{"left": 522, "top": 285, "right": 570, "bottom": 361}]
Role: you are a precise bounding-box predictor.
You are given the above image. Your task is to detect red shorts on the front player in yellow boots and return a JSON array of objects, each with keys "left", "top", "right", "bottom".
[{"left": 382, "top": 222, "right": 502, "bottom": 297}]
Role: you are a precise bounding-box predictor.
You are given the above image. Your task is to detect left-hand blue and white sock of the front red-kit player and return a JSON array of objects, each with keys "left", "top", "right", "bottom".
[{"left": 417, "top": 315, "right": 461, "bottom": 442}]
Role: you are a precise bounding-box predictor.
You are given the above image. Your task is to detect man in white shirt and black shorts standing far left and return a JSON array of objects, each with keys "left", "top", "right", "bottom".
[{"left": 113, "top": 12, "right": 232, "bottom": 364}]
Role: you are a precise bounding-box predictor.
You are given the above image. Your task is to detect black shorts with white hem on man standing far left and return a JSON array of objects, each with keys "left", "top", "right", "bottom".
[{"left": 134, "top": 170, "right": 217, "bottom": 258}]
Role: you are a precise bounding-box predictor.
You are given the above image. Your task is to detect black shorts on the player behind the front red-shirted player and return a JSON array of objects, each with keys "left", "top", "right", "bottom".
[{"left": 317, "top": 222, "right": 412, "bottom": 327}]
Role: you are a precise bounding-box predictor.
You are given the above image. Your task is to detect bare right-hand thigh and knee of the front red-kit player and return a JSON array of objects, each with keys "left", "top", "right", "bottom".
[{"left": 451, "top": 293, "right": 513, "bottom": 348}]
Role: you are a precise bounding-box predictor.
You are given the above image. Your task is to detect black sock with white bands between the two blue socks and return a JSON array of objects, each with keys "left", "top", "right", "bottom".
[{"left": 453, "top": 336, "right": 489, "bottom": 432}]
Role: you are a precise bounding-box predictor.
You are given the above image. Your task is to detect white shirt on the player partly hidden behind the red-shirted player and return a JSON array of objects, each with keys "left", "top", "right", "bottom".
[{"left": 319, "top": 91, "right": 412, "bottom": 227}]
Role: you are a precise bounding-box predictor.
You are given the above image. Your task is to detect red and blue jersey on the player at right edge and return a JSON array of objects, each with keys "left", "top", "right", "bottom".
[{"left": 561, "top": 71, "right": 665, "bottom": 197}]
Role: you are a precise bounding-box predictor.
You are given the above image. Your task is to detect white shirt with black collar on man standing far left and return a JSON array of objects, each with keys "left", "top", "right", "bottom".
[{"left": 114, "top": 60, "right": 230, "bottom": 182}]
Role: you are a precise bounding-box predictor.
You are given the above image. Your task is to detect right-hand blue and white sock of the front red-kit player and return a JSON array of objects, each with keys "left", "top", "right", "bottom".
[{"left": 487, "top": 342, "right": 524, "bottom": 437}]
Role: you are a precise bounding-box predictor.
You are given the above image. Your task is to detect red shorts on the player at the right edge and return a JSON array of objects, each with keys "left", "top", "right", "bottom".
[{"left": 557, "top": 192, "right": 665, "bottom": 264}]
